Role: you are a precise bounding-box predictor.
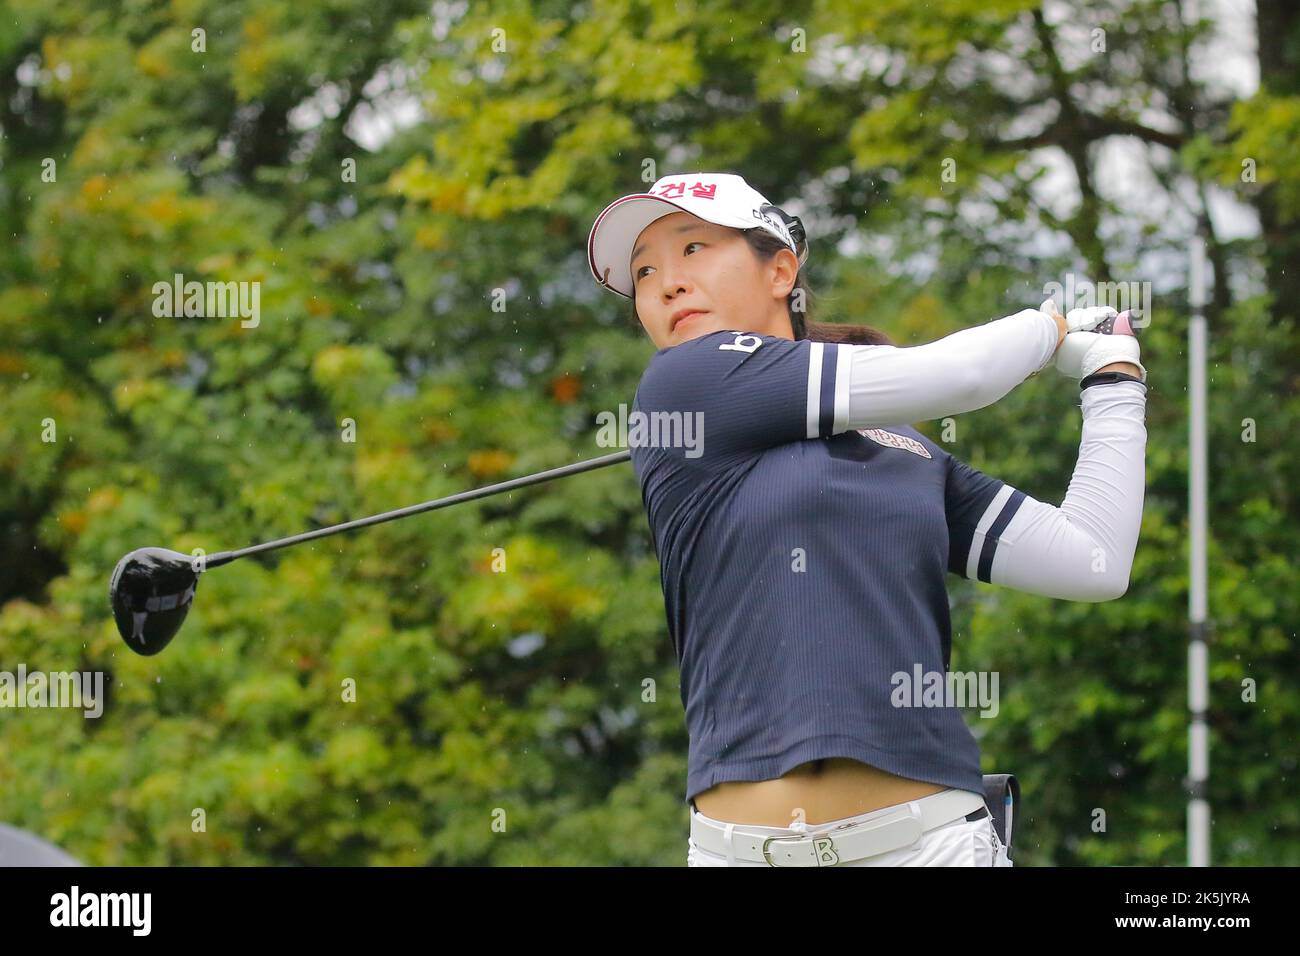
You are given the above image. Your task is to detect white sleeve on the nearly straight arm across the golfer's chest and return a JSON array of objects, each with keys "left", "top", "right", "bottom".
[{"left": 832, "top": 308, "right": 1060, "bottom": 437}]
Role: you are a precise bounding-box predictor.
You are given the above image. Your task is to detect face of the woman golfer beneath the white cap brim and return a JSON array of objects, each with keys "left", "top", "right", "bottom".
[{"left": 631, "top": 212, "right": 770, "bottom": 349}]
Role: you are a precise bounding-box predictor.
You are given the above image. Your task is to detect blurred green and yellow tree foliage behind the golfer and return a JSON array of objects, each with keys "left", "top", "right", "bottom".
[{"left": 0, "top": 0, "right": 1300, "bottom": 865}]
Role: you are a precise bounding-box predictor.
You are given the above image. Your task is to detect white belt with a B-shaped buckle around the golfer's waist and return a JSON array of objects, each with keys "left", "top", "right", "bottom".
[{"left": 690, "top": 788, "right": 988, "bottom": 866}]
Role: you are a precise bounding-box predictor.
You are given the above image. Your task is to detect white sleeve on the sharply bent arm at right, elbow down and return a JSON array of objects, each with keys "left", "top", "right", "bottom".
[{"left": 970, "top": 381, "right": 1147, "bottom": 601}]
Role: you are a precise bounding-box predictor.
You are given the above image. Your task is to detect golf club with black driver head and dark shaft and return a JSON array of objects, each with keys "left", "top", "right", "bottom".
[{"left": 108, "top": 450, "right": 632, "bottom": 657}]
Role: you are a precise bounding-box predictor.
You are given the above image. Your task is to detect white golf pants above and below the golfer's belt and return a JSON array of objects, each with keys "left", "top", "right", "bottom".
[{"left": 686, "top": 790, "right": 1011, "bottom": 866}]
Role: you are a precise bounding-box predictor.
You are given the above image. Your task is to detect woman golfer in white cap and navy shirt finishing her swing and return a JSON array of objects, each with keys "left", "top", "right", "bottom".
[{"left": 589, "top": 173, "right": 1147, "bottom": 866}]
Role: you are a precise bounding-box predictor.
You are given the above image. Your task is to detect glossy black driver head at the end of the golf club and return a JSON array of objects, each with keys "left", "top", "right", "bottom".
[{"left": 108, "top": 548, "right": 199, "bottom": 657}]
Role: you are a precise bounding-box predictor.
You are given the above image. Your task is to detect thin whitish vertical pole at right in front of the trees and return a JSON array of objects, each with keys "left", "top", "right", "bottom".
[{"left": 1187, "top": 235, "right": 1206, "bottom": 866}]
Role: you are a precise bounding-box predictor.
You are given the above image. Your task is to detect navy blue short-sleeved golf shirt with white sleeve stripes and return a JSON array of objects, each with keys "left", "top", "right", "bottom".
[{"left": 628, "top": 332, "right": 1024, "bottom": 800}]
